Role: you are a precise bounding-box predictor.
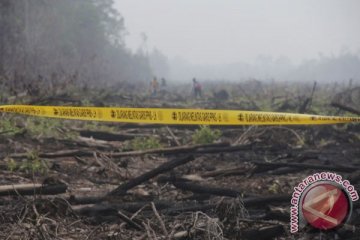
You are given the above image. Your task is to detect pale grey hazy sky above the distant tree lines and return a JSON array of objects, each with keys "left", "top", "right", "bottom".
[{"left": 115, "top": 0, "right": 360, "bottom": 64}]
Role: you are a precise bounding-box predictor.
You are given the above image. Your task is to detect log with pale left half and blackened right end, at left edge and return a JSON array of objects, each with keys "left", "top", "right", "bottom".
[{"left": 0, "top": 183, "right": 67, "bottom": 196}]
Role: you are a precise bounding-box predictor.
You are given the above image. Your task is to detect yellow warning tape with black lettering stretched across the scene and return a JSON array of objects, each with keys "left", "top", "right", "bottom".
[{"left": 0, "top": 105, "right": 360, "bottom": 125}]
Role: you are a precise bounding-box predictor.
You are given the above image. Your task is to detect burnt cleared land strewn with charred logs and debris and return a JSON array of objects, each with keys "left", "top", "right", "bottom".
[{"left": 0, "top": 81, "right": 360, "bottom": 239}]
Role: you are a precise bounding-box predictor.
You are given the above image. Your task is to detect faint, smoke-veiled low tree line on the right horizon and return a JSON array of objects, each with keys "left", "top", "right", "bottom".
[{"left": 170, "top": 51, "right": 360, "bottom": 82}]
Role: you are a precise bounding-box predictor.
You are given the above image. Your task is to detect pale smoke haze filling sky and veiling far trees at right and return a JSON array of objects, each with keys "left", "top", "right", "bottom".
[{"left": 115, "top": 0, "right": 360, "bottom": 81}]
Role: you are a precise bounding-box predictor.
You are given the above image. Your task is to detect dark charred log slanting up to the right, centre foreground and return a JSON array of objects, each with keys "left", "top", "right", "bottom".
[{"left": 108, "top": 155, "right": 195, "bottom": 196}]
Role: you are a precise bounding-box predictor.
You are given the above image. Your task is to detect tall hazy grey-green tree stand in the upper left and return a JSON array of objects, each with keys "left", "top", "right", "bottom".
[{"left": 0, "top": 0, "right": 152, "bottom": 84}]
